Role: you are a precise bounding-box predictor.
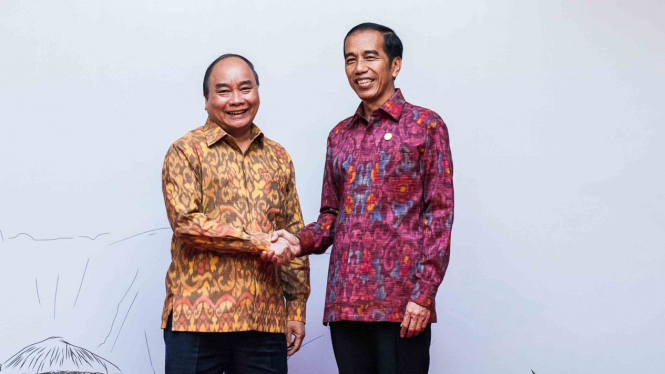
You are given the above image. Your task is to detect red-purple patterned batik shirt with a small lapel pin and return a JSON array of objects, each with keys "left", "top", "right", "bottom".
[{"left": 298, "top": 90, "right": 453, "bottom": 323}]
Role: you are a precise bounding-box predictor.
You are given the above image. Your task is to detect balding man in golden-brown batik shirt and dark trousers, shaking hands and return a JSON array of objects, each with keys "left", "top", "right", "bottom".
[{"left": 162, "top": 54, "right": 310, "bottom": 374}]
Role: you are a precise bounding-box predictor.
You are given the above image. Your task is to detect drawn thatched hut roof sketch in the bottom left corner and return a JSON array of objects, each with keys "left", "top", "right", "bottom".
[{"left": 0, "top": 337, "right": 122, "bottom": 374}]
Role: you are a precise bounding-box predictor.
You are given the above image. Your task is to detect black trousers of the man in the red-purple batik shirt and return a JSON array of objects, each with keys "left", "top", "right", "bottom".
[{"left": 330, "top": 321, "right": 432, "bottom": 374}]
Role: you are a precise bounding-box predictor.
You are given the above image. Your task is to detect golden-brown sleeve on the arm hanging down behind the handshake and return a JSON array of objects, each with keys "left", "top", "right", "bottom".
[{"left": 280, "top": 158, "right": 310, "bottom": 322}]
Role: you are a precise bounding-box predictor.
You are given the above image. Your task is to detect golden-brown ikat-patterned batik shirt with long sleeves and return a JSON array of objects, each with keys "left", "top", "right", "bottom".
[{"left": 162, "top": 119, "right": 310, "bottom": 332}]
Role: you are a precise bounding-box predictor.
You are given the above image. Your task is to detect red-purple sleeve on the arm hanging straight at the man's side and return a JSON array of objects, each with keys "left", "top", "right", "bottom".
[{"left": 409, "top": 115, "right": 454, "bottom": 307}]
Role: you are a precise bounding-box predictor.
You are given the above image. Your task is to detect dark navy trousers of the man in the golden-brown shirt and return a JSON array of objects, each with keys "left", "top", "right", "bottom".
[{"left": 164, "top": 317, "right": 288, "bottom": 374}]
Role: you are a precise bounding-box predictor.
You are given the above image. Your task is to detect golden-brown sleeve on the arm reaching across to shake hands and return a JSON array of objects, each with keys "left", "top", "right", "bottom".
[{"left": 162, "top": 144, "right": 270, "bottom": 254}]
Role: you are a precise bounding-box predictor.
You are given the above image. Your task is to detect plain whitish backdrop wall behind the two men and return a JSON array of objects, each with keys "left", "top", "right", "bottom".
[{"left": 0, "top": 0, "right": 665, "bottom": 374}]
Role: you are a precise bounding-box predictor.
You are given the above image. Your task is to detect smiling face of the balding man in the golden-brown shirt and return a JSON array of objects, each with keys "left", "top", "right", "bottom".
[{"left": 205, "top": 57, "right": 260, "bottom": 138}]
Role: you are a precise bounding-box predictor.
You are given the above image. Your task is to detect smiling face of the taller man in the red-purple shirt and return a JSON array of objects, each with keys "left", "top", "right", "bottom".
[{"left": 344, "top": 30, "right": 402, "bottom": 114}]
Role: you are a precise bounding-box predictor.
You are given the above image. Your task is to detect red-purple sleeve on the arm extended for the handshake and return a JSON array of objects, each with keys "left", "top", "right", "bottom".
[{"left": 298, "top": 136, "right": 340, "bottom": 254}]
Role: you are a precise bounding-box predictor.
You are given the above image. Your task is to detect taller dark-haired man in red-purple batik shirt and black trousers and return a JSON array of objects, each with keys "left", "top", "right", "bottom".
[{"left": 263, "top": 23, "right": 453, "bottom": 374}]
